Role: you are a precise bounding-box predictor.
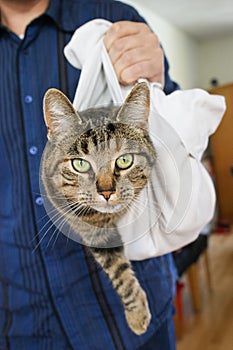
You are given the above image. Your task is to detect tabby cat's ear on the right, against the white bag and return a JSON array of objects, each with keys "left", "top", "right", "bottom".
[{"left": 117, "top": 82, "right": 150, "bottom": 129}]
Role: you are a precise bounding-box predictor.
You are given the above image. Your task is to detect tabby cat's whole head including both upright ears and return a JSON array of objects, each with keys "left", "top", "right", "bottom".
[{"left": 43, "top": 83, "right": 155, "bottom": 215}]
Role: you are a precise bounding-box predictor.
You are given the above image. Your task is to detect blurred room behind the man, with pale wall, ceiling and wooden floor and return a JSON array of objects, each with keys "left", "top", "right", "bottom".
[{"left": 125, "top": 0, "right": 233, "bottom": 350}]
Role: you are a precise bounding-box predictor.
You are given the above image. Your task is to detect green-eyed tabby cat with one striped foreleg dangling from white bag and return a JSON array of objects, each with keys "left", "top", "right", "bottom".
[{"left": 41, "top": 82, "right": 156, "bottom": 335}]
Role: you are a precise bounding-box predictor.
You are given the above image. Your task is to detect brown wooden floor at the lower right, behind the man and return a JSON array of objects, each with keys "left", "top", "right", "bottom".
[{"left": 177, "top": 231, "right": 233, "bottom": 350}]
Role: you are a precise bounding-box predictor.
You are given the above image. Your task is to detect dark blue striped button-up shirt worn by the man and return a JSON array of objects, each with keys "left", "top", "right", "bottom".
[{"left": 0, "top": 0, "right": 177, "bottom": 350}]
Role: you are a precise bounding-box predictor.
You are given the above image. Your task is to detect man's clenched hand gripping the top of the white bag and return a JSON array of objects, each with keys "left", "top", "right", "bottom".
[{"left": 104, "top": 21, "right": 164, "bottom": 85}]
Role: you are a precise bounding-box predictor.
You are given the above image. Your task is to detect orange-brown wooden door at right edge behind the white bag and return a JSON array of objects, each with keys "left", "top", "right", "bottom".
[{"left": 210, "top": 84, "right": 233, "bottom": 224}]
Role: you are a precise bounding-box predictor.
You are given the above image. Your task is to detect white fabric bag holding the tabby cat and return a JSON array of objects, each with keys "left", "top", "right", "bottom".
[{"left": 65, "top": 19, "right": 225, "bottom": 260}]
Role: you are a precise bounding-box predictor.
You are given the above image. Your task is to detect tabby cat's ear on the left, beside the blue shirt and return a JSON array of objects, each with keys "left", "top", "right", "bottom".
[{"left": 43, "top": 88, "right": 81, "bottom": 140}]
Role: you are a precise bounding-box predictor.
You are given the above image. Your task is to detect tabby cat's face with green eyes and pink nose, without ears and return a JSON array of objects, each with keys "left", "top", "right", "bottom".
[{"left": 61, "top": 123, "right": 153, "bottom": 213}]
